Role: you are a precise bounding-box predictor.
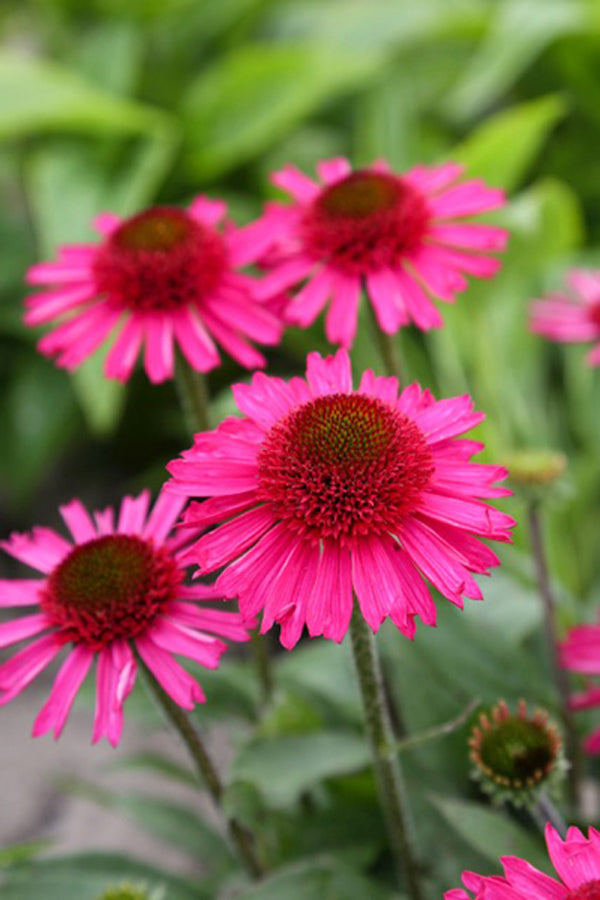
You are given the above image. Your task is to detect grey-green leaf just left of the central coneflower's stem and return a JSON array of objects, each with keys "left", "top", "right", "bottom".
[{"left": 229, "top": 731, "right": 371, "bottom": 808}]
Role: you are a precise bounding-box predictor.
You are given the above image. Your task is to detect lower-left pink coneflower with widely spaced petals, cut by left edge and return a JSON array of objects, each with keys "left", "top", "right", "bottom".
[{"left": 0, "top": 491, "right": 248, "bottom": 746}]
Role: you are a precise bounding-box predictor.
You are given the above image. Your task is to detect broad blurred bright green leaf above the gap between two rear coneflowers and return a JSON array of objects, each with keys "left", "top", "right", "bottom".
[{"left": 182, "top": 44, "right": 382, "bottom": 176}]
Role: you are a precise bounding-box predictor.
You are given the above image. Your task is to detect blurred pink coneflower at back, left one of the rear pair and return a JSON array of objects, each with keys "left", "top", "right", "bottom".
[{"left": 25, "top": 197, "right": 281, "bottom": 382}]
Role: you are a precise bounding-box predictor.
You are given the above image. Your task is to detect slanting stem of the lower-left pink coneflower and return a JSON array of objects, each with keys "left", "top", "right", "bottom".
[{"left": 141, "top": 663, "right": 264, "bottom": 879}]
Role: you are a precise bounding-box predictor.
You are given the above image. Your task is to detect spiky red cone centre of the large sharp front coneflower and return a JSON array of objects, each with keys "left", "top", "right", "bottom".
[{"left": 258, "top": 394, "right": 433, "bottom": 541}]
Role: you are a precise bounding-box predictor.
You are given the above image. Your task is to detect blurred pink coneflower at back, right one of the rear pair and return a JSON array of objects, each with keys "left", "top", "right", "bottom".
[{"left": 232, "top": 158, "right": 507, "bottom": 347}]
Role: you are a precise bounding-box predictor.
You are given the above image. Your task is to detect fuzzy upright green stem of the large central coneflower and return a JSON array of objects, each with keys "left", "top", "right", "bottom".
[{"left": 350, "top": 604, "right": 423, "bottom": 900}]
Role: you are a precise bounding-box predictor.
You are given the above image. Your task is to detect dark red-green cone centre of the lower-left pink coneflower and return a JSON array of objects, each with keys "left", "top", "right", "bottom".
[{"left": 40, "top": 534, "right": 183, "bottom": 650}]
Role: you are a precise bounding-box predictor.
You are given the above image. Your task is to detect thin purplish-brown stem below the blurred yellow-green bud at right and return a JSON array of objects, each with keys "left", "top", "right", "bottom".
[{"left": 527, "top": 500, "right": 581, "bottom": 810}]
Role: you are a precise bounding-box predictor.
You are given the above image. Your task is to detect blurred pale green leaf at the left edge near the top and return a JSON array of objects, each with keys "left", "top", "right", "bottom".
[{"left": 0, "top": 52, "right": 167, "bottom": 139}]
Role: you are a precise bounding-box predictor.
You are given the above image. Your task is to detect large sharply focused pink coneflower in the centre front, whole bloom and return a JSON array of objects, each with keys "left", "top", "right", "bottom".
[{"left": 168, "top": 350, "right": 514, "bottom": 647}]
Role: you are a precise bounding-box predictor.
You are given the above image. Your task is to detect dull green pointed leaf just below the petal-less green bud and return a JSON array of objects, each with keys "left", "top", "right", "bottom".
[{"left": 430, "top": 795, "right": 549, "bottom": 871}]
